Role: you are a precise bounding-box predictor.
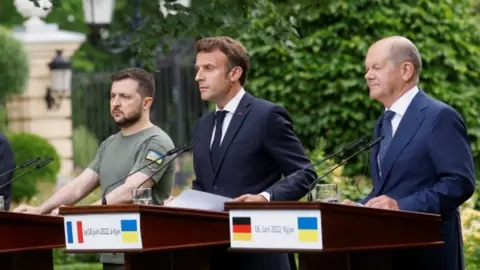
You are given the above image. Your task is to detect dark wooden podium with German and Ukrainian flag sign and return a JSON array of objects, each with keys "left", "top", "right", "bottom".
[{"left": 225, "top": 202, "right": 444, "bottom": 270}]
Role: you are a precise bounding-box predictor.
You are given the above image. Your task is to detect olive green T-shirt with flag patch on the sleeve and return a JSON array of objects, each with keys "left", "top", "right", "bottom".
[{"left": 89, "top": 126, "right": 175, "bottom": 264}]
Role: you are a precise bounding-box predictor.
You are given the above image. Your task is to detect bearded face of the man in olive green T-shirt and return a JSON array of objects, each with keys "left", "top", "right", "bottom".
[{"left": 110, "top": 78, "right": 143, "bottom": 128}]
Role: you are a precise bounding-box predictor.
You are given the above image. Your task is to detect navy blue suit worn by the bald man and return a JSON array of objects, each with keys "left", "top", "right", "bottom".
[{"left": 361, "top": 90, "right": 475, "bottom": 270}]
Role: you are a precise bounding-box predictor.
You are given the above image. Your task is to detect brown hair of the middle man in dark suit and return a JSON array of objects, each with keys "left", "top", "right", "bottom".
[{"left": 196, "top": 36, "right": 250, "bottom": 85}]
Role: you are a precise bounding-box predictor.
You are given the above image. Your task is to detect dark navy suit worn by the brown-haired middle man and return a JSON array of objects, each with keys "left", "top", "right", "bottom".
[{"left": 193, "top": 93, "right": 316, "bottom": 270}]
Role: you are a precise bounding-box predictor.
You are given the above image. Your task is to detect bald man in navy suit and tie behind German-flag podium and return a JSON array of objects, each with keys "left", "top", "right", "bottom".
[{"left": 344, "top": 36, "right": 475, "bottom": 270}]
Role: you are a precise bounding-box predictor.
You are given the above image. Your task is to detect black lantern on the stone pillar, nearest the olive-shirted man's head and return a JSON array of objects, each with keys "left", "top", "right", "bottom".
[{"left": 45, "top": 50, "right": 72, "bottom": 110}]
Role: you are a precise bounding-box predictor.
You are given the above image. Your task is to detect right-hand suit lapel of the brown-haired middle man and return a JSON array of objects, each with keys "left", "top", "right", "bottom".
[{"left": 215, "top": 93, "right": 253, "bottom": 177}]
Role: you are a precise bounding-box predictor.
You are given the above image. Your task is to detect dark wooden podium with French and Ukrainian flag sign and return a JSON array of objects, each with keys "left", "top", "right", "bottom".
[{"left": 60, "top": 204, "right": 229, "bottom": 270}]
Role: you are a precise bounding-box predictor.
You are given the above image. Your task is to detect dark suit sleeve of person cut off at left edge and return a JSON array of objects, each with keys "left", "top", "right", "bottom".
[{"left": 0, "top": 133, "right": 16, "bottom": 210}]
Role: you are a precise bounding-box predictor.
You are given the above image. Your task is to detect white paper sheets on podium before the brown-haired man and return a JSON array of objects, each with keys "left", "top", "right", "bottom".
[{"left": 165, "top": 189, "right": 232, "bottom": 211}]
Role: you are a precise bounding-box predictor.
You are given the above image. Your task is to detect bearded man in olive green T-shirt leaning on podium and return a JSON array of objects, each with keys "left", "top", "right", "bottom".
[{"left": 13, "top": 68, "right": 175, "bottom": 269}]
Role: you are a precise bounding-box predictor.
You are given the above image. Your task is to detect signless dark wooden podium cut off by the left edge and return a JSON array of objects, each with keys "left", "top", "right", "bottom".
[{"left": 0, "top": 212, "right": 65, "bottom": 270}]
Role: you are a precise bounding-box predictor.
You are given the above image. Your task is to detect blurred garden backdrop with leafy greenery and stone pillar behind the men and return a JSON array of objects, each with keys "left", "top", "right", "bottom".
[{"left": 0, "top": 0, "right": 480, "bottom": 270}]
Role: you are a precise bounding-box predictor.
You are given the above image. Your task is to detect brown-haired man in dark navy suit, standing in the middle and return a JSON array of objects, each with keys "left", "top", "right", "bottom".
[{"left": 189, "top": 37, "right": 316, "bottom": 270}]
